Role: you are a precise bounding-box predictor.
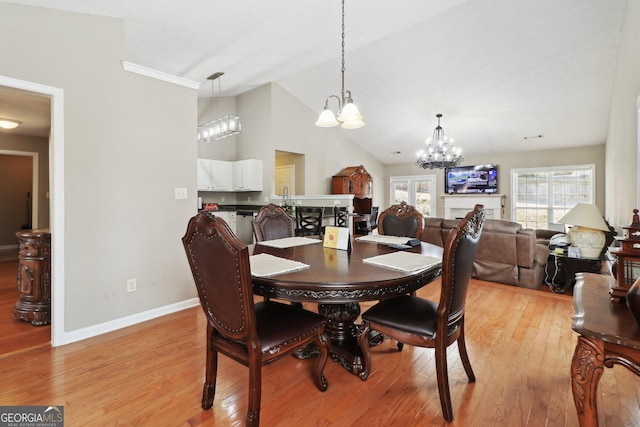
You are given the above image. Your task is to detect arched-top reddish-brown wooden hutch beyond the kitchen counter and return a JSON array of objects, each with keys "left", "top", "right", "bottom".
[{"left": 331, "top": 165, "right": 373, "bottom": 214}]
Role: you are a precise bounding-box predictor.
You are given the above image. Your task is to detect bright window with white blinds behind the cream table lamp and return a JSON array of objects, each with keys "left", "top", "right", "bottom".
[{"left": 511, "top": 165, "right": 595, "bottom": 229}]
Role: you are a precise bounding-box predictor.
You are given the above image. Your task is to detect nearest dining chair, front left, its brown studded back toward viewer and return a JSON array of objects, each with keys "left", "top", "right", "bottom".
[{"left": 182, "top": 212, "right": 328, "bottom": 426}]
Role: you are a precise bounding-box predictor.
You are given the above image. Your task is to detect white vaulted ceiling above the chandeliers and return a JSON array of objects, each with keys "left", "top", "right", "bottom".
[{"left": 0, "top": 0, "right": 625, "bottom": 164}]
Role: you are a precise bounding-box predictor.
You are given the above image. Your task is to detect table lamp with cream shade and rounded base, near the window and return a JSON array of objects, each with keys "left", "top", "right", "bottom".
[{"left": 558, "top": 203, "right": 609, "bottom": 258}]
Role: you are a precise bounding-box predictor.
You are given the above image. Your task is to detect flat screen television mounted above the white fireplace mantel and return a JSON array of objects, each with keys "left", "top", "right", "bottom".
[{"left": 444, "top": 164, "right": 498, "bottom": 194}]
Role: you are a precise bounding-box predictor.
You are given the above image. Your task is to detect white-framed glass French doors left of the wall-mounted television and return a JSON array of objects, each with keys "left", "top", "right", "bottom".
[{"left": 389, "top": 175, "right": 436, "bottom": 217}]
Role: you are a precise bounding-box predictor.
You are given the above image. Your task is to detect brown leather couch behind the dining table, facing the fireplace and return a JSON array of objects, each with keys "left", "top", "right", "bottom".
[{"left": 420, "top": 218, "right": 549, "bottom": 289}]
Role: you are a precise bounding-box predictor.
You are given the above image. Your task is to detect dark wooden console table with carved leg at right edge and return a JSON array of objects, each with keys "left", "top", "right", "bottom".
[{"left": 571, "top": 273, "right": 640, "bottom": 427}]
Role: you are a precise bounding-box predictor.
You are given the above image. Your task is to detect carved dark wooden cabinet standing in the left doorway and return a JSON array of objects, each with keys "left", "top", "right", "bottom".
[{"left": 13, "top": 229, "right": 51, "bottom": 326}]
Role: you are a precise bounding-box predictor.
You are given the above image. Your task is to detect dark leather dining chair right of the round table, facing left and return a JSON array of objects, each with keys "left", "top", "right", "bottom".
[{"left": 359, "top": 205, "right": 485, "bottom": 421}]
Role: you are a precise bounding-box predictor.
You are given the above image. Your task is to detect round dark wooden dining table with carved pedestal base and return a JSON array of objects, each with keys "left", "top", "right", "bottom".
[{"left": 249, "top": 240, "right": 443, "bottom": 375}]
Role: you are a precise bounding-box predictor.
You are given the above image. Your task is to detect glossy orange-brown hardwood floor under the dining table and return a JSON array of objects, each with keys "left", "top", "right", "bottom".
[{"left": 0, "top": 263, "right": 640, "bottom": 427}]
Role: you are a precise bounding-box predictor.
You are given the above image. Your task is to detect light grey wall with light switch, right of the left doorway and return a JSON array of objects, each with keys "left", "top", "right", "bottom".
[{"left": 0, "top": 3, "right": 197, "bottom": 335}]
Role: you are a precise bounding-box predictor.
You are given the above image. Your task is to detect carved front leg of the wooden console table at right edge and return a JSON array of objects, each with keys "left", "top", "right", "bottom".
[{"left": 571, "top": 336, "right": 604, "bottom": 427}]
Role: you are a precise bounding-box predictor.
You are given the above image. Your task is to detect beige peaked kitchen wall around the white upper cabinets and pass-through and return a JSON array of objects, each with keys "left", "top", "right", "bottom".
[{"left": 200, "top": 83, "right": 384, "bottom": 209}]
